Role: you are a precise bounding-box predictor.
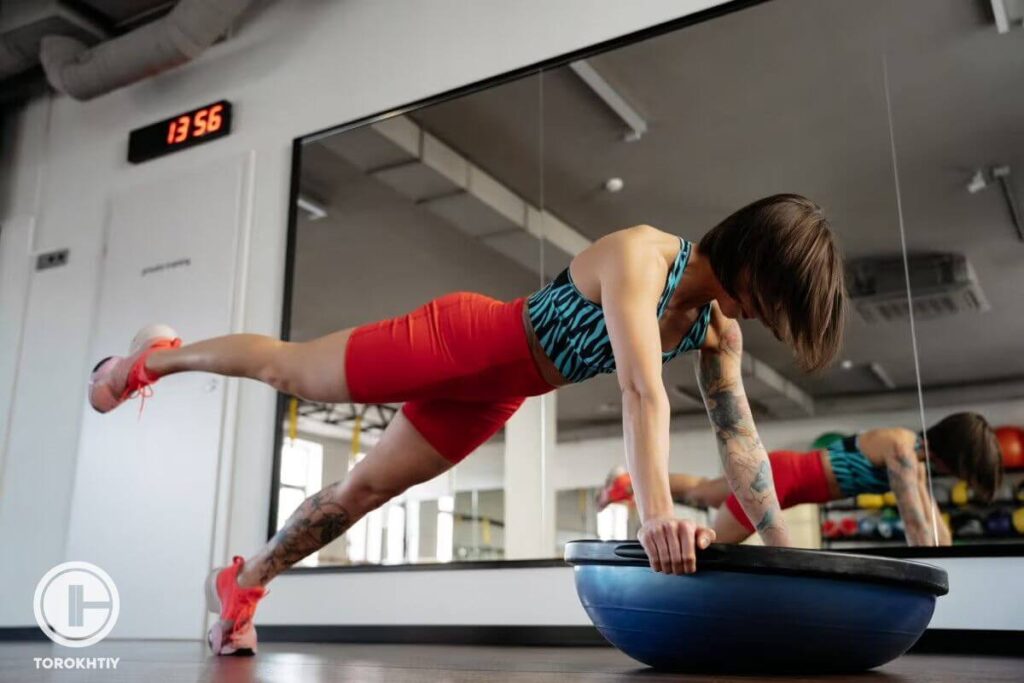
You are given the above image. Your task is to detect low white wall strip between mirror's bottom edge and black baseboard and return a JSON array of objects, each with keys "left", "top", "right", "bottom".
[{"left": 253, "top": 557, "right": 1024, "bottom": 631}]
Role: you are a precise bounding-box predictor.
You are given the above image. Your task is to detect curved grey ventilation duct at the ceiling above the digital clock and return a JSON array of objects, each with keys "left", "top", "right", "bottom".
[{"left": 39, "top": 0, "right": 252, "bottom": 100}]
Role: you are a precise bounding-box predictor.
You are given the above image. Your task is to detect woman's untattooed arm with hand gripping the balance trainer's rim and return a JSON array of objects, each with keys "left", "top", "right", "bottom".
[{"left": 598, "top": 232, "right": 714, "bottom": 573}]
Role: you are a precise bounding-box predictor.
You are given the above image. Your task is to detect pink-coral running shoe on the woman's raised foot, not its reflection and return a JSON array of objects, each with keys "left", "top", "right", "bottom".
[{"left": 89, "top": 325, "right": 181, "bottom": 413}]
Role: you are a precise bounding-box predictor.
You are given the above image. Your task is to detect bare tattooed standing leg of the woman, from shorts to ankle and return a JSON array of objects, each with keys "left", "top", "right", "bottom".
[{"left": 239, "top": 412, "right": 453, "bottom": 588}]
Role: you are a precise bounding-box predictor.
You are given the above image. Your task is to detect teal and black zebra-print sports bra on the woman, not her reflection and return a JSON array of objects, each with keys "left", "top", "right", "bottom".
[{"left": 526, "top": 238, "right": 711, "bottom": 383}]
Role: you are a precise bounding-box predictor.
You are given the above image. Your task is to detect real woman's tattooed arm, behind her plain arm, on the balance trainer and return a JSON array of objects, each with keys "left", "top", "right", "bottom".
[{"left": 697, "top": 304, "right": 790, "bottom": 546}]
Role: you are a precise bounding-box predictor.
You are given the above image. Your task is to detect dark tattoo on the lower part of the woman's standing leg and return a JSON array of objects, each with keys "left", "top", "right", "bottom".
[{"left": 260, "top": 482, "right": 352, "bottom": 583}]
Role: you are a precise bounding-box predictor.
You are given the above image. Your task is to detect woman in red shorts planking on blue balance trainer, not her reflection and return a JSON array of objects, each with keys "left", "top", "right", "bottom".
[{"left": 89, "top": 195, "right": 846, "bottom": 654}]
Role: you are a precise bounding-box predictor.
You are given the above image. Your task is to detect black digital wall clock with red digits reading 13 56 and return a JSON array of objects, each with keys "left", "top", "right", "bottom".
[{"left": 128, "top": 100, "right": 231, "bottom": 164}]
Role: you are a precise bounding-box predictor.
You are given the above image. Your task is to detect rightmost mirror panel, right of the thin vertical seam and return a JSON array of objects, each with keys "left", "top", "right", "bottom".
[{"left": 880, "top": 2, "right": 1024, "bottom": 552}]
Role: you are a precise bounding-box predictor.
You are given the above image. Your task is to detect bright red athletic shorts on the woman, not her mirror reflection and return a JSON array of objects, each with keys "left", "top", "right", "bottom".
[{"left": 345, "top": 292, "right": 554, "bottom": 463}]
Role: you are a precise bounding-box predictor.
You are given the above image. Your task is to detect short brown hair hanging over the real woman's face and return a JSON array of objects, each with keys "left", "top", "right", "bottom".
[{"left": 698, "top": 195, "right": 846, "bottom": 370}]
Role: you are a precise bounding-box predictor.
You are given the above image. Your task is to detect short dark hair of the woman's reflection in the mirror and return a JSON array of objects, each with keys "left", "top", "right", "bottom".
[{"left": 925, "top": 413, "right": 1002, "bottom": 502}]
